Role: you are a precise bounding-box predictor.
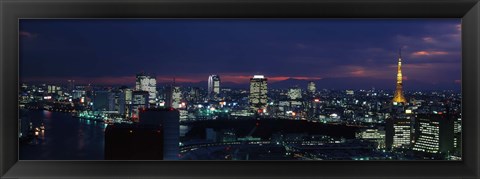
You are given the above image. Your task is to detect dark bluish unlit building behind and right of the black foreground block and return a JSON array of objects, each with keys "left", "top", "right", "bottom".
[{"left": 139, "top": 108, "right": 180, "bottom": 160}]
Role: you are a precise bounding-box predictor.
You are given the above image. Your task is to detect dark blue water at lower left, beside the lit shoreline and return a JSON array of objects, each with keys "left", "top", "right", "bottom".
[{"left": 19, "top": 110, "right": 106, "bottom": 160}]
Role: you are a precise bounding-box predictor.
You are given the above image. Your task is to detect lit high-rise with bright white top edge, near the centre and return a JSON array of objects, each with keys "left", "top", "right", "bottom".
[{"left": 249, "top": 75, "right": 268, "bottom": 112}]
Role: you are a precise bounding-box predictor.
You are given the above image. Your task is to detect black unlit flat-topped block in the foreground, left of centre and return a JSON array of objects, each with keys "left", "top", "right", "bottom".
[{"left": 105, "top": 124, "right": 164, "bottom": 160}]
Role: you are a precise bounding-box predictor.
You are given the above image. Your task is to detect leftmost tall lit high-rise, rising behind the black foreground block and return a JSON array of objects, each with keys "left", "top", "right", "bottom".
[{"left": 135, "top": 73, "right": 157, "bottom": 104}]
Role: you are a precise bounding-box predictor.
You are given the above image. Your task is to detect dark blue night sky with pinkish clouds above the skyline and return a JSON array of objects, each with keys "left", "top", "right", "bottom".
[{"left": 19, "top": 19, "right": 461, "bottom": 89}]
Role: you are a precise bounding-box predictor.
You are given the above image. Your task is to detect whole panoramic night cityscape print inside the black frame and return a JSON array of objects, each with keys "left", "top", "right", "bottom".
[{"left": 18, "top": 19, "right": 463, "bottom": 160}]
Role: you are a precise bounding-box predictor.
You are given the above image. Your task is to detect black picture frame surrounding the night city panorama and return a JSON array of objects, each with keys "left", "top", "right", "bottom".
[{"left": 0, "top": 0, "right": 480, "bottom": 179}]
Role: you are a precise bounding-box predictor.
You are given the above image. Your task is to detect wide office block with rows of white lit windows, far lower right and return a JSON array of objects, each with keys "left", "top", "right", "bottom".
[{"left": 413, "top": 114, "right": 455, "bottom": 153}]
